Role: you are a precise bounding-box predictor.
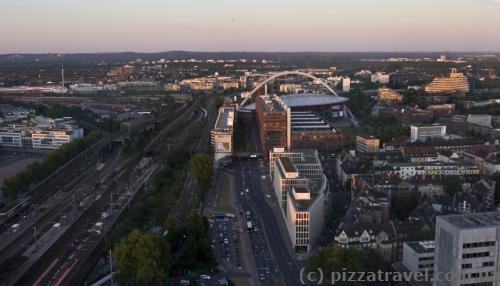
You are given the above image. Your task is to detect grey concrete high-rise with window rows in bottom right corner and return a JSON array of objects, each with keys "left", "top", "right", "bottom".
[{"left": 434, "top": 212, "right": 500, "bottom": 286}]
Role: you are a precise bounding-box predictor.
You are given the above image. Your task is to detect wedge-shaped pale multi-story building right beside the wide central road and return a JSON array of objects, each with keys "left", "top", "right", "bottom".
[{"left": 270, "top": 150, "right": 328, "bottom": 252}]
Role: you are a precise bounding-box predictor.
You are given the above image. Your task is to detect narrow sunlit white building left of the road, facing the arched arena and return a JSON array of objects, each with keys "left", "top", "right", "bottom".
[{"left": 211, "top": 106, "right": 235, "bottom": 164}]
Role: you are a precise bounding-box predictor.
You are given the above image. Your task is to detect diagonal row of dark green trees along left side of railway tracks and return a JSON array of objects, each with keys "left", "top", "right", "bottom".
[{"left": 2, "top": 131, "right": 102, "bottom": 199}]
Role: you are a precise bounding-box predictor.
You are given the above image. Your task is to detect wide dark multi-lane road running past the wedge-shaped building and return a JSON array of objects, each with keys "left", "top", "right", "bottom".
[{"left": 207, "top": 125, "right": 303, "bottom": 286}]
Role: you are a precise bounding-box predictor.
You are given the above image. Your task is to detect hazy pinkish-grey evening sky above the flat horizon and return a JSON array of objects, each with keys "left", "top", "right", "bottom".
[{"left": 0, "top": 0, "right": 500, "bottom": 53}]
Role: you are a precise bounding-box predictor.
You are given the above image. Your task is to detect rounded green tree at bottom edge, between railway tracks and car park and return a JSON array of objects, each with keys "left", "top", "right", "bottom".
[{"left": 113, "top": 229, "right": 171, "bottom": 285}]
